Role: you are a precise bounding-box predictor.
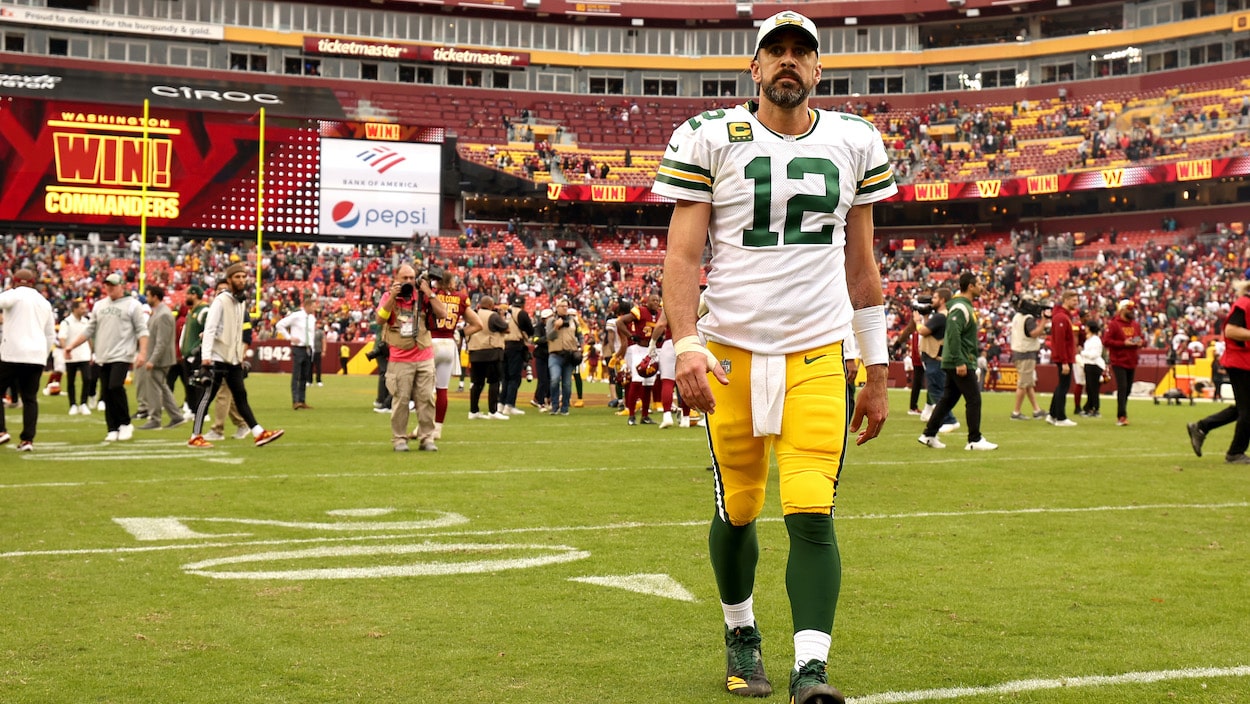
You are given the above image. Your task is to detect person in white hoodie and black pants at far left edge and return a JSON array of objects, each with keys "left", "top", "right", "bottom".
[{"left": 0, "top": 269, "right": 56, "bottom": 453}]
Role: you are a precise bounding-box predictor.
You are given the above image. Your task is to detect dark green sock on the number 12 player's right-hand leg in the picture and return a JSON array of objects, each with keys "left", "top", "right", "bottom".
[{"left": 785, "top": 514, "right": 843, "bottom": 633}]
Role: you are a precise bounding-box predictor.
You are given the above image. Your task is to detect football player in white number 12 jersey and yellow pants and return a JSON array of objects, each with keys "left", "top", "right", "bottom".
[{"left": 653, "top": 10, "right": 898, "bottom": 704}]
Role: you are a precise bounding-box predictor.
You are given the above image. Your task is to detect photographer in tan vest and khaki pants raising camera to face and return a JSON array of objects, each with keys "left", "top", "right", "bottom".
[{"left": 378, "top": 264, "right": 448, "bottom": 453}]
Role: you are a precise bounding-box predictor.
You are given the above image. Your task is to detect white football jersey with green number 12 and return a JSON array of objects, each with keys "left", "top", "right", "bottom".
[{"left": 651, "top": 103, "right": 898, "bottom": 354}]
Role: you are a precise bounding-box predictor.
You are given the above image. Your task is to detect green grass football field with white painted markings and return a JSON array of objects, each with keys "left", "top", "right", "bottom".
[{"left": 0, "top": 375, "right": 1250, "bottom": 704}]
